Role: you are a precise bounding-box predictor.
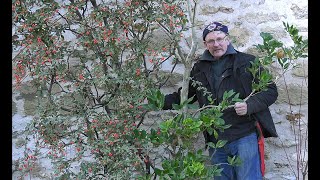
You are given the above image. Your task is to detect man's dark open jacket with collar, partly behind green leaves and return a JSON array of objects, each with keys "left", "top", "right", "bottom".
[{"left": 164, "top": 46, "right": 278, "bottom": 142}]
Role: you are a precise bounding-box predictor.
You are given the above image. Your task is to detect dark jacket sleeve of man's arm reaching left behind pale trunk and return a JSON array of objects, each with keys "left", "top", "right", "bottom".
[{"left": 163, "top": 66, "right": 197, "bottom": 110}]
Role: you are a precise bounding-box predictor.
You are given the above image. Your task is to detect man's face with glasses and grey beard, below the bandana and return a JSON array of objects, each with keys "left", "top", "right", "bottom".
[{"left": 204, "top": 31, "right": 230, "bottom": 59}]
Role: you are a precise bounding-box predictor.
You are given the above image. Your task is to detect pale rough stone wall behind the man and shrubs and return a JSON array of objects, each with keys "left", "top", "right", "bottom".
[{"left": 12, "top": 0, "right": 308, "bottom": 180}]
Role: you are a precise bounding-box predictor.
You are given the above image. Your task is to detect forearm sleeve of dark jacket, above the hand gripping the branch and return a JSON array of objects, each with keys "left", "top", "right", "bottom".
[{"left": 246, "top": 68, "right": 278, "bottom": 114}]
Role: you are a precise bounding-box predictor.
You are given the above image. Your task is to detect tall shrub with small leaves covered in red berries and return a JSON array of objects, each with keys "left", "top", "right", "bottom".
[{"left": 12, "top": 0, "right": 187, "bottom": 179}]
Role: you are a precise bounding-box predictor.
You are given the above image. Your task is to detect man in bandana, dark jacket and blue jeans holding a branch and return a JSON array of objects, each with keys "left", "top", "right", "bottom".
[{"left": 164, "top": 22, "right": 278, "bottom": 180}]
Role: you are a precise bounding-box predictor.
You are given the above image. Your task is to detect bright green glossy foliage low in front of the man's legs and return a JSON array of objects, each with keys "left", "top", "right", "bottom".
[{"left": 144, "top": 88, "right": 241, "bottom": 179}]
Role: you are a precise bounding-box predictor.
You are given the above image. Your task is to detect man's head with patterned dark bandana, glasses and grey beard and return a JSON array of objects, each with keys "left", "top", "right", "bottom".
[{"left": 202, "top": 22, "right": 230, "bottom": 58}]
